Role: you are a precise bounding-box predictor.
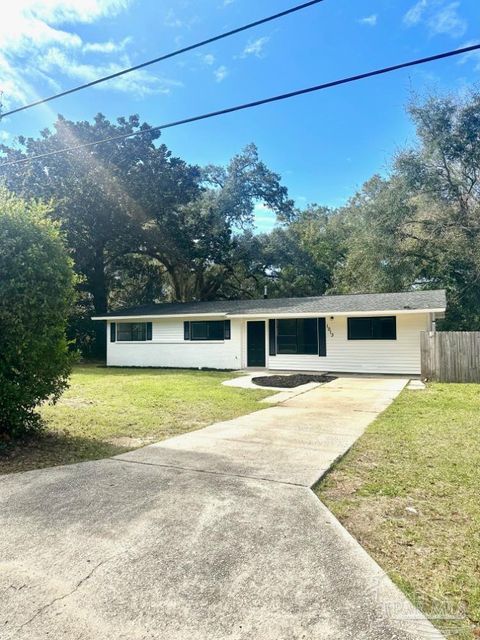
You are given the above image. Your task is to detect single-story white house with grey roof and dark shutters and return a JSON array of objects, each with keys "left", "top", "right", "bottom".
[{"left": 94, "top": 290, "right": 446, "bottom": 374}]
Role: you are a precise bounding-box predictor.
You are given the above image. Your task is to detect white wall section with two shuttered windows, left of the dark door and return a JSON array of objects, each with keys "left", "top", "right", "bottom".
[{"left": 107, "top": 318, "right": 242, "bottom": 369}]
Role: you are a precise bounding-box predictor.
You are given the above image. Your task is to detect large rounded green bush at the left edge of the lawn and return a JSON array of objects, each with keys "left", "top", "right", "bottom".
[{"left": 0, "top": 189, "right": 74, "bottom": 443}]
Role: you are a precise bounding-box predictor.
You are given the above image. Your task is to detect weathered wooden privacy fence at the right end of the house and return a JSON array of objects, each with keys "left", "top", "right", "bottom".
[{"left": 420, "top": 331, "right": 480, "bottom": 382}]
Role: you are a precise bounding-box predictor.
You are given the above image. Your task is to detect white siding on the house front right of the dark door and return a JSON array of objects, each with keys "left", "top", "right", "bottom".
[{"left": 268, "top": 313, "right": 430, "bottom": 374}]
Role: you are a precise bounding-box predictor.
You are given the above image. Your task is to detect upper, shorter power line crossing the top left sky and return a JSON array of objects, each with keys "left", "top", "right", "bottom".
[{"left": 0, "top": 0, "right": 324, "bottom": 120}]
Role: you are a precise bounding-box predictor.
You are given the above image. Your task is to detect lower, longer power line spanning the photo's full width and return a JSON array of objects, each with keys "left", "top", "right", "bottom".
[{"left": 0, "top": 44, "right": 480, "bottom": 169}]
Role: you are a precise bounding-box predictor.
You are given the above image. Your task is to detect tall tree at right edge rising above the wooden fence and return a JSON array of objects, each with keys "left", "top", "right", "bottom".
[{"left": 396, "top": 91, "right": 480, "bottom": 330}]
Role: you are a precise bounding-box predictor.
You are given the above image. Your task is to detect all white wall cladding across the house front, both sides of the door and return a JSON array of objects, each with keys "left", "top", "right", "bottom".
[{"left": 107, "top": 313, "right": 430, "bottom": 374}]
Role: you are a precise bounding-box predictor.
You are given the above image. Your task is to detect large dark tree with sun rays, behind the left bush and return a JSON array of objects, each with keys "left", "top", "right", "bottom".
[{"left": 0, "top": 114, "right": 199, "bottom": 355}]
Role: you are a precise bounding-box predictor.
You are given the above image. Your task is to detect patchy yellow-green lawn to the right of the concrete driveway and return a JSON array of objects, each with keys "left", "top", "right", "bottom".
[{"left": 316, "top": 384, "right": 480, "bottom": 639}]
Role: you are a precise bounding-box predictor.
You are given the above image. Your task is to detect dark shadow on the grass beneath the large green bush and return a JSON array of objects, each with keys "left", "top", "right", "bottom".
[{"left": 0, "top": 431, "right": 132, "bottom": 475}]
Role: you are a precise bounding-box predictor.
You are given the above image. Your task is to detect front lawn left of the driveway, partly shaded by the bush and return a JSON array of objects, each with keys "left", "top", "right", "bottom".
[{"left": 0, "top": 365, "right": 271, "bottom": 473}]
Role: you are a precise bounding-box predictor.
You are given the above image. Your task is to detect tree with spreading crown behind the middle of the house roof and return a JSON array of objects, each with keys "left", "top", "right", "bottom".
[{"left": 135, "top": 145, "right": 294, "bottom": 301}]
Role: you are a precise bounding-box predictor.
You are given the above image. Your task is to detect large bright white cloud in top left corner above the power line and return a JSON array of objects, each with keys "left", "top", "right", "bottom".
[{"left": 0, "top": 0, "right": 179, "bottom": 110}]
